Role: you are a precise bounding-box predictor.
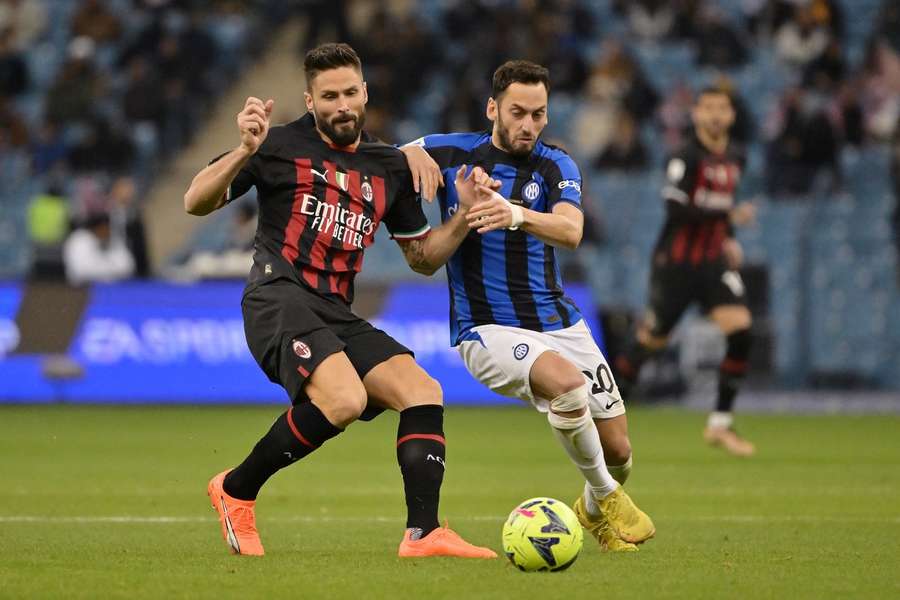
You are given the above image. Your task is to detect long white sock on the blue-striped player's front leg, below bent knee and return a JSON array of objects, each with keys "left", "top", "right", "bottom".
[{"left": 547, "top": 411, "right": 619, "bottom": 498}]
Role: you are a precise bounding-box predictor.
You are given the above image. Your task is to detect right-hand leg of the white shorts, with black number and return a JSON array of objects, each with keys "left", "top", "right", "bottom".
[{"left": 545, "top": 320, "right": 625, "bottom": 419}]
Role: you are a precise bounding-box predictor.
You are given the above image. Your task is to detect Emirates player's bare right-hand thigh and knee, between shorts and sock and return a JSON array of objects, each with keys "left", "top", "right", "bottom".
[{"left": 363, "top": 354, "right": 443, "bottom": 412}]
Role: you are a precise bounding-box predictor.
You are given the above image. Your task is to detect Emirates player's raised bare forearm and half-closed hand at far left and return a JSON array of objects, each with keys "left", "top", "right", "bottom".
[{"left": 184, "top": 97, "right": 274, "bottom": 216}]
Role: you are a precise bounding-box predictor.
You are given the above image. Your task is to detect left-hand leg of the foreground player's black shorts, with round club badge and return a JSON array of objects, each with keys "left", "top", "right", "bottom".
[{"left": 241, "top": 282, "right": 348, "bottom": 403}]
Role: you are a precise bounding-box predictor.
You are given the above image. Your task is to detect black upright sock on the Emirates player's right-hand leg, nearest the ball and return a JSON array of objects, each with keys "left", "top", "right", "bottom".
[{"left": 397, "top": 404, "right": 445, "bottom": 537}]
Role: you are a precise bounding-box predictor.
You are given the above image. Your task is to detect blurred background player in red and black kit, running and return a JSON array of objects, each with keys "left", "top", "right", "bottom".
[{"left": 616, "top": 88, "right": 756, "bottom": 456}]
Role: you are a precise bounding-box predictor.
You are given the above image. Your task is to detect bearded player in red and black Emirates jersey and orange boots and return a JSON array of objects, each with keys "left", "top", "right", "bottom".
[{"left": 185, "top": 44, "right": 496, "bottom": 558}]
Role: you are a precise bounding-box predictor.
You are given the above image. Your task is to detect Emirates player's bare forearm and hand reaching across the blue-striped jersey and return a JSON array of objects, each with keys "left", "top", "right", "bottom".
[{"left": 398, "top": 165, "right": 500, "bottom": 276}]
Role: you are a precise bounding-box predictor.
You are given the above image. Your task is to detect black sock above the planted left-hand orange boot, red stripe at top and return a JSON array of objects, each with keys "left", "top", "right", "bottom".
[{"left": 222, "top": 402, "right": 343, "bottom": 500}]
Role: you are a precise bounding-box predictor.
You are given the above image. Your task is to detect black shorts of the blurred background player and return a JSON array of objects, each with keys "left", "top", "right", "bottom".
[{"left": 645, "top": 254, "right": 747, "bottom": 337}]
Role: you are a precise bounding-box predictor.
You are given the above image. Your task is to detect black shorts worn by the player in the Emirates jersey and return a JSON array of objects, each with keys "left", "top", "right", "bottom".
[{"left": 241, "top": 279, "right": 412, "bottom": 412}]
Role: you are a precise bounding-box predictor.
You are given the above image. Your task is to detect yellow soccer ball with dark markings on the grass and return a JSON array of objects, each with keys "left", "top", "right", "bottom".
[{"left": 503, "top": 498, "right": 584, "bottom": 571}]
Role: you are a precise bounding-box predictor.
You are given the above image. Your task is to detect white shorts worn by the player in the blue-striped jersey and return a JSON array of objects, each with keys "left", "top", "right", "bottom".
[{"left": 457, "top": 319, "right": 625, "bottom": 419}]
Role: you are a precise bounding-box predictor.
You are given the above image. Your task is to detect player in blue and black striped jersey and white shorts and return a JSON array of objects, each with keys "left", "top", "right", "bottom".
[{"left": 403, "top": 61, "right": 655, "bottom": 551}]
